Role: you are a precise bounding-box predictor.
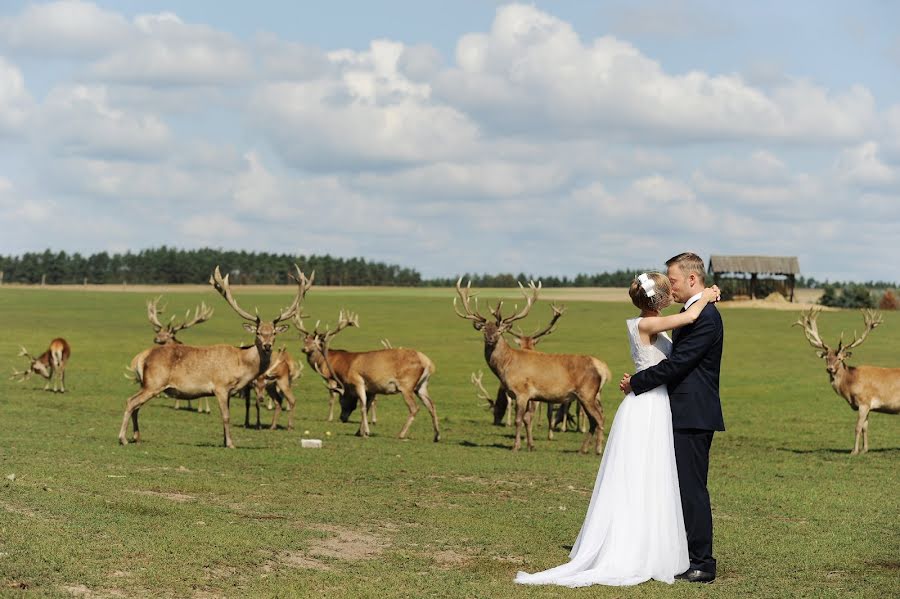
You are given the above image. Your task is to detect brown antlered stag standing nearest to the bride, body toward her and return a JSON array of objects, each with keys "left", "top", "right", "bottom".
[{"left": 453, "top": 277, "right": 611, "bottom": 455}]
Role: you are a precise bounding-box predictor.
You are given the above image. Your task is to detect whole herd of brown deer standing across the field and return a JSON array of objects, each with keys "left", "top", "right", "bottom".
[{"left": 11, "top": 265, "right": 900, "bottom": 455}]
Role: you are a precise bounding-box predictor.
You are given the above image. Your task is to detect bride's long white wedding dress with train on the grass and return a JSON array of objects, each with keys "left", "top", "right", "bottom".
[{"left": 516, "top": 318, "right": 690, "bottom": 587}]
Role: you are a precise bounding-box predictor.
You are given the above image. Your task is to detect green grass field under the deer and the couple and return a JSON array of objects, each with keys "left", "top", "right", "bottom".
[{"left": 0, "top": 287, "right": 900, "bottom": 598}]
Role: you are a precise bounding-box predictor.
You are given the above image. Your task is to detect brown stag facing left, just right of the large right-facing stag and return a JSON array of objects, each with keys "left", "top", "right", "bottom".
[{"left": 294, "top": 310, "right": 441, "bottom": 443}]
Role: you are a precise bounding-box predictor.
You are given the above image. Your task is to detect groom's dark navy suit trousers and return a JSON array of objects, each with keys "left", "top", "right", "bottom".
[{"left": 674, "top": 429, "right": 716, "bottom": 574}]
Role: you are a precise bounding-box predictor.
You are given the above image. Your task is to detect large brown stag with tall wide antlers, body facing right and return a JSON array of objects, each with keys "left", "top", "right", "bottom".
[{"left": 119, "top": 265, "right": 315, "bottom": 449}]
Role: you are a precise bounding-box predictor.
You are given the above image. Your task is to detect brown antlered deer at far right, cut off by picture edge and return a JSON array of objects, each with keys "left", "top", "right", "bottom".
[{"left": 794, "top": 308, "right": 900, "bottom": 455}]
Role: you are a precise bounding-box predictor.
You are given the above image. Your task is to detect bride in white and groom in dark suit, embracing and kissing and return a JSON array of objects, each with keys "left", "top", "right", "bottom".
[{"left": 516, "top": 253, "right": 725, "bottom": 587}]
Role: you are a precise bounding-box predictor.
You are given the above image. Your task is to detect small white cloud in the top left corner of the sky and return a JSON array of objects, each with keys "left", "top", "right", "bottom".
[{"left": 0, "top": 0, "right": 131, "bottom": 58}]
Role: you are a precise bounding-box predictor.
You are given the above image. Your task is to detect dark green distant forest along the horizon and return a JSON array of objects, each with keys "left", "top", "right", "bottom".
[{"left": 0, "top": 246, "right": 895, "bottom": 288}]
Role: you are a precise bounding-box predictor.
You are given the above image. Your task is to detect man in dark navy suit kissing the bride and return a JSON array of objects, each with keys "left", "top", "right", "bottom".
[{"left": 619, "top": 252, "right": 725, "bottom": 582}]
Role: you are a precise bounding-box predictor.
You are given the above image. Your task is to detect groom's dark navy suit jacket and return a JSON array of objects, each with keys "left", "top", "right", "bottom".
[{"left": 631, "top": 304, "right": 725, "bottom": 431}]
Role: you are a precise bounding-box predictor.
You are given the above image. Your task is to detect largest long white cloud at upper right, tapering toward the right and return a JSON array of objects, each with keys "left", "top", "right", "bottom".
[{"left": 434, "top": 4, "right": 874, "bottom": 143}]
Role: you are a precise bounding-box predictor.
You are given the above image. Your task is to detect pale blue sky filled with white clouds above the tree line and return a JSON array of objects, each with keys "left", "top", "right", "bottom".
[{"left": 0, "top": 0, "right": 900, "bottom": 281}]
